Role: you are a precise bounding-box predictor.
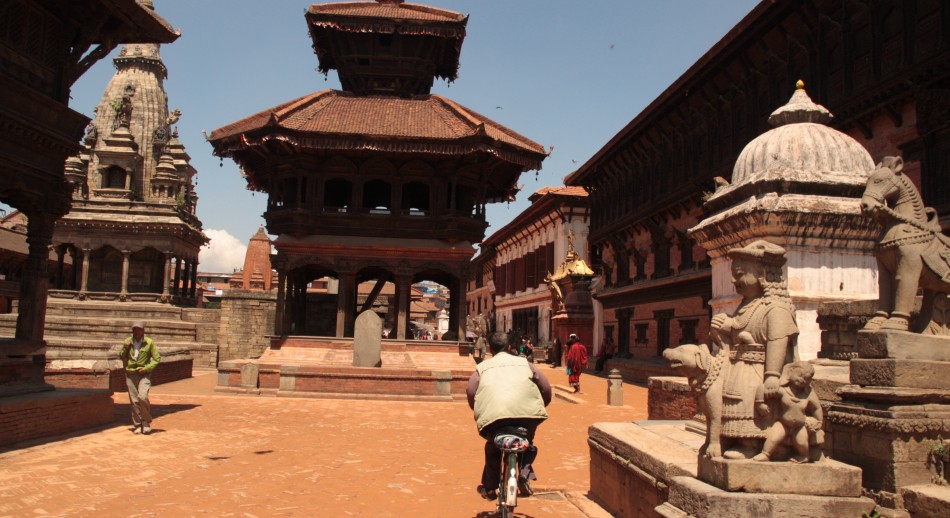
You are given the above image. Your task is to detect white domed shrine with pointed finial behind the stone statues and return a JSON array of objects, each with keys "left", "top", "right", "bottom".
[{"left": 689, "top": 82, "right": 879, "bottom": 360}]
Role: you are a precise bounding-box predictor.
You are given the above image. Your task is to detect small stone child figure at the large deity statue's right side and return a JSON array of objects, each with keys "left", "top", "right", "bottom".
[{"left": 752, "top": 361, "right": 824, "bottom": 463}]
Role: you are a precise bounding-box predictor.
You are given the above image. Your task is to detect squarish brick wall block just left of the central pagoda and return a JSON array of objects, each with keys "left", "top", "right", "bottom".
[{"left": 217, "top": 289, "right": 277, "bottom": 363}]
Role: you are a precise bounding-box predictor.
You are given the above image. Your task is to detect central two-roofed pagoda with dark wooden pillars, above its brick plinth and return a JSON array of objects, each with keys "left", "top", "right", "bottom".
[{"left": 209, "top": 0, "right": 547, "bottom": 339}]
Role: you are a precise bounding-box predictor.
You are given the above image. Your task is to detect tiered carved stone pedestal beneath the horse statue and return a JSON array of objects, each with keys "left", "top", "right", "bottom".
[{"left": 827, "top": 331, "right": 950, "bottom": 514}]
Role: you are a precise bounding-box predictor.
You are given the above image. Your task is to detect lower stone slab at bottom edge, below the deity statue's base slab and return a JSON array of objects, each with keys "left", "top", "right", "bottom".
[{"left": 656, "top": 477, "right": 875, "bottom": 518}]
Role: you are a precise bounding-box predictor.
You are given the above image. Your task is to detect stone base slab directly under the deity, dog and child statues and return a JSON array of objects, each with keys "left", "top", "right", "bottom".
[{"left": 698, "top": 457, "right": 861, "bottom": 497}]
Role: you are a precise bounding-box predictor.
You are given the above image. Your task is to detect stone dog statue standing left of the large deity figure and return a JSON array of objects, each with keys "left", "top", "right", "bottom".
[{"left": 663, "top": 344, "right": 729, "bottom": 458}]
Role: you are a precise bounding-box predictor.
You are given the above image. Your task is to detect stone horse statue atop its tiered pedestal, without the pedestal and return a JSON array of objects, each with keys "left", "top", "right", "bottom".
[{"left": 861, "top": 157, "right": 950, "bottom": 332}]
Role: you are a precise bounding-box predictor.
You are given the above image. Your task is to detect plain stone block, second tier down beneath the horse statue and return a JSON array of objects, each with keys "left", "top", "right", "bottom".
[{"left": 851, "top": 358, "right": 950, "bottom": 389}]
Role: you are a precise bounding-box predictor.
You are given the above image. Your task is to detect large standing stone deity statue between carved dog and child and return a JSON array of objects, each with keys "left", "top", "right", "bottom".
[{"left": 707, "top": 240, "right": 798, "bottom": 459}]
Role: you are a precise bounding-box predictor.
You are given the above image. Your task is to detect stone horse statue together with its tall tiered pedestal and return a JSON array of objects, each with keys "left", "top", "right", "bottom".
[{"left": 827, "top": 153, "right": 950, "bottom": 516}]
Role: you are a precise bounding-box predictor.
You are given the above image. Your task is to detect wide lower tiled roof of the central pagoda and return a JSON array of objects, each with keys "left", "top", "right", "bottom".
[{"left": 209, "top": 90, "right": 547, "bottom": 169}]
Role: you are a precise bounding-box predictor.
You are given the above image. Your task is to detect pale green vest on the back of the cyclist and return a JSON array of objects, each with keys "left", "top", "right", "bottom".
[{"left": 475, "top": 353, "right": 548, "bottom": 432}]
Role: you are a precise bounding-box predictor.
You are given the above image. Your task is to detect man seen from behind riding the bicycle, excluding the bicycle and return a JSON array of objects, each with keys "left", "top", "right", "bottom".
[{"left": 466, "top": 333, "right": 551, "bottom": 500}]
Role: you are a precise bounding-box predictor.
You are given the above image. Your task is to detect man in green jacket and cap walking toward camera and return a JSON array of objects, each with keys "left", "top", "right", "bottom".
[{"left": 119, "top": 321, "right": 162, "bottom": 435}]
